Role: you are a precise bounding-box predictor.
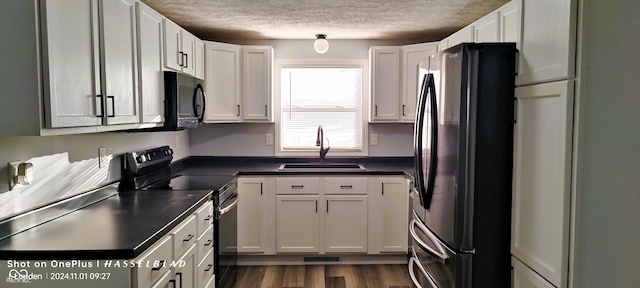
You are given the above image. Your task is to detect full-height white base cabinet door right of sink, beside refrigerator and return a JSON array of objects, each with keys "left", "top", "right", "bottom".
[{"left": 369, "top": 177, "right": 409, "bottom": 254}]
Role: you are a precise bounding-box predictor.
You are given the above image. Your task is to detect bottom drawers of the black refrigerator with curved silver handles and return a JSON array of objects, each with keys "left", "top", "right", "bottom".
[{"left": 409, "top": 212, "right": 472, "bottom": 288}]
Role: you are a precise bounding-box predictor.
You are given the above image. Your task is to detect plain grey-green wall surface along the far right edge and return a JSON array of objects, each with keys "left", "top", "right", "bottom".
[{"left": 573, "top": 0, "right": 640, "bottom": 288}]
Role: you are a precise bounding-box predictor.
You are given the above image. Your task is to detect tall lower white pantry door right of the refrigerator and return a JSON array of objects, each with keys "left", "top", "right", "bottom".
[{"left": 511, "top": 81, "right": 573, "bottom": 287}]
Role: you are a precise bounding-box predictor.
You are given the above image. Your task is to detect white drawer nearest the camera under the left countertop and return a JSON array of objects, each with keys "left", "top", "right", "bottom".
[{"left": 133, "top": 236, "right": 173, "bottom": 288}]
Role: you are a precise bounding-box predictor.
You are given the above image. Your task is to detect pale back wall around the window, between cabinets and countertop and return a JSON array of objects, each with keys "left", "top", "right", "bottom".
[{"left": 189, "top": 38, "right": 413, "bottom": 157}]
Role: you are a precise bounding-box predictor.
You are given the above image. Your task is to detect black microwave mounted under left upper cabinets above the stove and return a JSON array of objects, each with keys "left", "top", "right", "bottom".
[{"left": 163, "top": 71, "right": 206, "bottom": 130}]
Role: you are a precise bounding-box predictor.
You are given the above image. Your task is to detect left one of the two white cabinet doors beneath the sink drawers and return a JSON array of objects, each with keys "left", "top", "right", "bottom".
[{"left": 276, "top": 195, "right": 322, "bottom": 253}]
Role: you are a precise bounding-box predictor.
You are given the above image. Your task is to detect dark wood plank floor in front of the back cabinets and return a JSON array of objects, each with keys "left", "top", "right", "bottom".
[{"left": 235, "top": 265, "right": 411, "bottom": 288}]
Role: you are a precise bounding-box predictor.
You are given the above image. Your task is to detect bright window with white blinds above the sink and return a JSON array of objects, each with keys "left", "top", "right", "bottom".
[{"left": 276, "top": 60, "right": 368, "bottom": 156}]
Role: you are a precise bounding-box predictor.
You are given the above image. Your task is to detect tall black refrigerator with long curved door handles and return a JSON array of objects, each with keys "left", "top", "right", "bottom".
[{"left": 408, "top": 43, "right": 516, "bottom": 288}]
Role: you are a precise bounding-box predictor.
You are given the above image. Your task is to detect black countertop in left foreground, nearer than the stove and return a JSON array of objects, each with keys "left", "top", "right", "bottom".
[{"left": 0, "top": 190, "right": 211, "bottom": 260}]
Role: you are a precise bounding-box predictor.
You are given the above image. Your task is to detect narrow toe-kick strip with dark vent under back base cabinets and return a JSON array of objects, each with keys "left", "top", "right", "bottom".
[{"left": 238, "top": 254, "right": 408, "bottom": 266}]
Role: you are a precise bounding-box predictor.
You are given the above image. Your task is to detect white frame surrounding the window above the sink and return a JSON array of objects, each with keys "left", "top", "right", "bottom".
[{"left": 274, "top": 59, "right": 369, "bottom": 158}]
